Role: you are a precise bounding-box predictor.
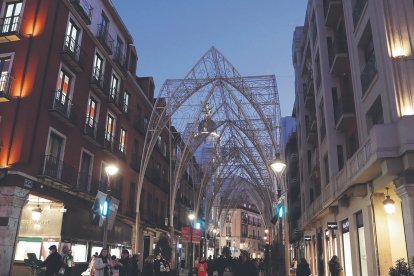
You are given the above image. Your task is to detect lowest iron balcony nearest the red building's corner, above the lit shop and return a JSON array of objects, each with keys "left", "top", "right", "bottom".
[{"left": 41, "top": 155, "right": 77, "bottom": 188}]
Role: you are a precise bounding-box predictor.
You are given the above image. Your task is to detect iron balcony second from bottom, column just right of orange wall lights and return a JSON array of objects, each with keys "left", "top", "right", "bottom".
[{"left": 49, "top": 90, "right": 79, "bottom": 127}]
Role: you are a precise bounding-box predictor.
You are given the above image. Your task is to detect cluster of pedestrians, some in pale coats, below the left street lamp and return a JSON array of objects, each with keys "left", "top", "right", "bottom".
[{"left": 86, "top": 248, "right": 138, "bottom": 276}]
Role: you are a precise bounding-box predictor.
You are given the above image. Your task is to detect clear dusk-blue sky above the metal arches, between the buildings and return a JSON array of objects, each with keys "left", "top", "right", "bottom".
[{"left": 112, "top": 0, "right": 307, "bottom": 116}]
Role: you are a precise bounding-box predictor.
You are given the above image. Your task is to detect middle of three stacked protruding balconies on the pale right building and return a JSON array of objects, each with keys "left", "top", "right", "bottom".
[{"left": 328, "top": 39, "right": 349, "bottom": 76}]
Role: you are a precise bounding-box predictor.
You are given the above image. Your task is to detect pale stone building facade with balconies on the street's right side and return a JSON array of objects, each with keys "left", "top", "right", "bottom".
[{"left": 291, "top": 0, "right": 414, "bottom": 275}]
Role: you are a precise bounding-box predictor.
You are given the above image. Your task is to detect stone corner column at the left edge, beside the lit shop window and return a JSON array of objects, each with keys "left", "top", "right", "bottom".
[{"left": 0, "top": 186, "right": 29, "bottom": 276}]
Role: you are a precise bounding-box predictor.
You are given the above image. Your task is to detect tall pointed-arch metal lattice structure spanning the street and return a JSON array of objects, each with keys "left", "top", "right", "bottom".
[{"left": 135, "top": 47, "right": 280, "bottom": 260}]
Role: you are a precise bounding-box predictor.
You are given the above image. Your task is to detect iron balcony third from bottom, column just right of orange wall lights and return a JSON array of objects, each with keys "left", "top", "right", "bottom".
[{"left": 61, "top": 35, "right": 85, "bottom": 73}]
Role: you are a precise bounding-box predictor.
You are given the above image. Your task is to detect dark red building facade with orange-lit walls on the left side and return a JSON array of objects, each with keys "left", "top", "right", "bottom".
[{"left": 0, "top": 0, "right": 192, "bottom": 275}]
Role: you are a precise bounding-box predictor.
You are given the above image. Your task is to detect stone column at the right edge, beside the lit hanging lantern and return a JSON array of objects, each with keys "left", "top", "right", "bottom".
[{"left": 396, "top": 184, "right": 414, "bottom": 261}]
